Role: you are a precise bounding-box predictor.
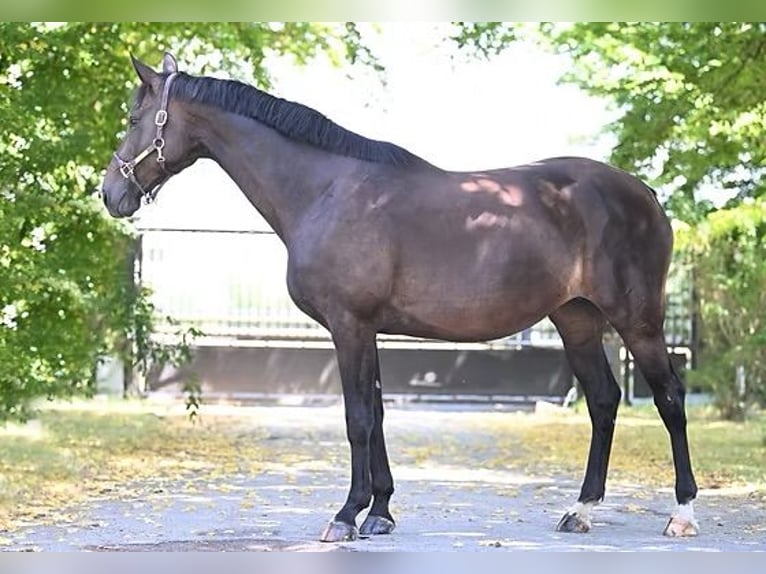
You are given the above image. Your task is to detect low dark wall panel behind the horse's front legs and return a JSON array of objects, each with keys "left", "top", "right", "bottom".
[{"left": 149, "top": 347, "right": 571, "bottom": 397}]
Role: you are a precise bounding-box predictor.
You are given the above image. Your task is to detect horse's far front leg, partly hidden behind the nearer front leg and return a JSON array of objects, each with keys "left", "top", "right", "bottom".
[{"left": 359, "top": 351, "right": 396, "bottom": 536}]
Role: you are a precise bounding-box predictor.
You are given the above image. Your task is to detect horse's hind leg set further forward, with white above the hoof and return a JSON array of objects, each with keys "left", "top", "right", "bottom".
[{"left": 550, "top": 299, "right": 620, "bottom": 532}]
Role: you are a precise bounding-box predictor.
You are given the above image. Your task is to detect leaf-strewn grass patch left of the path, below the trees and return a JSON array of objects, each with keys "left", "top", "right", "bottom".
[{"left": 0, "top": 403, "right": 262, "bottom": 530}]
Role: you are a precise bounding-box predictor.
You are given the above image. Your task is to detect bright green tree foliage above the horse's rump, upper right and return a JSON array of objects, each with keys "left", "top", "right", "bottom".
[{"left": 454, "top": 22, "right": 766, "bottom": 223}]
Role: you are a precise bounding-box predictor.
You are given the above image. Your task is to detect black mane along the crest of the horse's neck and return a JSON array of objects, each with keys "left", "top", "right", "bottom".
[{"left": 170, "top": 73, "right": 424, "bottom": 166}]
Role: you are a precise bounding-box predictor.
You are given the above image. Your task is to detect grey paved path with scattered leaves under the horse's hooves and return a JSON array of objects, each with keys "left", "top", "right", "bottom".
[{"left": 2, "top": 407, "right": 766, "bottom": 551}]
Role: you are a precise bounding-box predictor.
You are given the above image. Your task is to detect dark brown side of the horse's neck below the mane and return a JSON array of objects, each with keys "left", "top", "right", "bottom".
[{"left": 196, "top": 110, "right": 344, "bottom": 243}]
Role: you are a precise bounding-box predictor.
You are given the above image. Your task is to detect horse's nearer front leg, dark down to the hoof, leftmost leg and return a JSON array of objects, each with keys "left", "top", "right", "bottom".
[{"left": 320, "top": 319, "right": 376, "bottom": 542}]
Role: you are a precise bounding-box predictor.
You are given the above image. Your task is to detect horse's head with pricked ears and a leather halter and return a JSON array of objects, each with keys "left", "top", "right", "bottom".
[{"left": 103, "top": 54, "right": 193, "bottom": 217}]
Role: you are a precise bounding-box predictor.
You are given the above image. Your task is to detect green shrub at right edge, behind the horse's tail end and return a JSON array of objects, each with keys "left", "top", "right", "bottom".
[{"left": 677, "top": 199, "right": 766, "bottom": 419}]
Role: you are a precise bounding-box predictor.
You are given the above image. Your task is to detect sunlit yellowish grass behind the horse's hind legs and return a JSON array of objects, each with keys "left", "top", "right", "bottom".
[{"left": 486, "top": 407, "right": 766, "bottom": 492}]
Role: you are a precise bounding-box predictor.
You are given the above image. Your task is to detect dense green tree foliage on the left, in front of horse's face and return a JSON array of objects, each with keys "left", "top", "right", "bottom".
[{"left": 0, "top": 22, "right": 374, "bottom": 421}]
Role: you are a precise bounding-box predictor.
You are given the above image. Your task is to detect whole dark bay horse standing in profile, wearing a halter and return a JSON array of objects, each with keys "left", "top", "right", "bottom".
[{"left": 103, "top": 54, "right": 698, "bottom": 541}]
